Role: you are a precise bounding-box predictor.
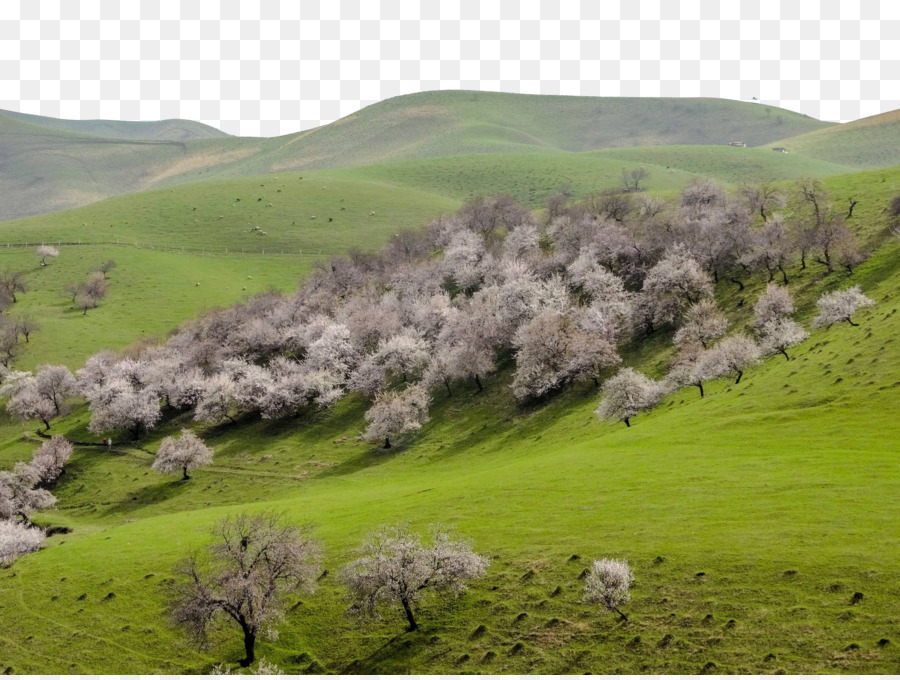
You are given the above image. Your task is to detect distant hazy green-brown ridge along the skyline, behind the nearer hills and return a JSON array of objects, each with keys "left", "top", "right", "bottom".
[{"left": 0, "top": 91, "right": 830, "bottom": 220}]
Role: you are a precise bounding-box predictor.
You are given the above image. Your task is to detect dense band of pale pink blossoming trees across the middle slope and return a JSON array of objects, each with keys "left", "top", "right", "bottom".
[{"left": 42, "top": 174, "right": 861, "bottom": 448}]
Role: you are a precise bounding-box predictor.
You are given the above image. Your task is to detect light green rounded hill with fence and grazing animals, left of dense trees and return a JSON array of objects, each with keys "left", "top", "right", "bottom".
[{"left": 0, "top": 175, "right": 459, "bottom": 368}]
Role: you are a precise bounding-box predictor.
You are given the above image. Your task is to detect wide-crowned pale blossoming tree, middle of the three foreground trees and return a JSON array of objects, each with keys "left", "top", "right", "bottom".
[{"left": 341, "top": 524, "right": 489, "bottom": 631}]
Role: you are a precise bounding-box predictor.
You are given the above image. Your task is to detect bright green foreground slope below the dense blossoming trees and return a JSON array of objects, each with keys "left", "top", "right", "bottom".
[{"left": 0, "top": 170, "right": 900, "bottom": 674}]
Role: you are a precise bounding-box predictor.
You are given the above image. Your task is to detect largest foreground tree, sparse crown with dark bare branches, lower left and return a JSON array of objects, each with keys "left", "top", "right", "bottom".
[{"left": 170, "top": 513, "right": 321, "bottom": 667}]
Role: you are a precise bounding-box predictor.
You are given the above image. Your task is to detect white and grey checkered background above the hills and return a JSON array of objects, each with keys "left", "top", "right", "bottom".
[{"left": 0, "top": 0, "right": 900, "bottom": 136}]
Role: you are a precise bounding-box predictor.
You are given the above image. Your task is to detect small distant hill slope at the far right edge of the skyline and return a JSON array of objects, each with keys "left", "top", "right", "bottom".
[{"left": 771, "top": 111, "right": 900, "bottom": 168}]
